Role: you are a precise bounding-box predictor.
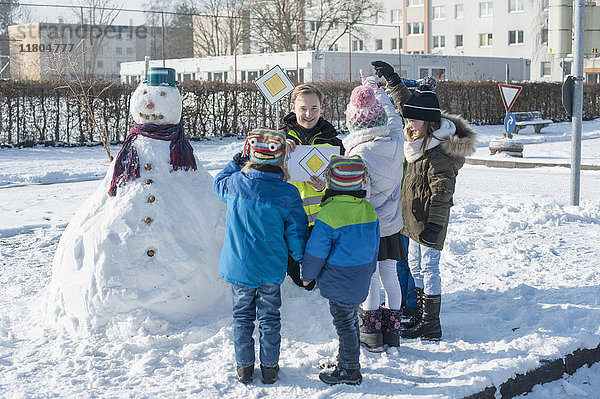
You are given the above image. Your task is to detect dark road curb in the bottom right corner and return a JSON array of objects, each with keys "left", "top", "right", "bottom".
[{"left": 463, "top": 344, "right": 600, "bottom": 399}]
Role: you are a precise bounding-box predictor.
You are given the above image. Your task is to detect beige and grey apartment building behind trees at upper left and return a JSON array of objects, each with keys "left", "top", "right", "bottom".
[{"left": 8, "top": 22, "right": 161, "bottom": 81}]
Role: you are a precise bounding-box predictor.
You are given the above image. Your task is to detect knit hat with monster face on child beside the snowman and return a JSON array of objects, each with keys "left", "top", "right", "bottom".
[{"left": 244, "top": 127, "right": 285, "bottom": 164}]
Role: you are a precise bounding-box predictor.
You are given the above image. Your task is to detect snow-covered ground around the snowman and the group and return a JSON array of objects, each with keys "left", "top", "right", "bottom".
[{"left": 0, "top": 120, "right": 600, "bottom": 399}]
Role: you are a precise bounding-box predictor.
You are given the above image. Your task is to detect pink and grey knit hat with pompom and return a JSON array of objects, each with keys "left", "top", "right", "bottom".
[{"left": 346, "top": 86, "right": 387, "bottom": 133}]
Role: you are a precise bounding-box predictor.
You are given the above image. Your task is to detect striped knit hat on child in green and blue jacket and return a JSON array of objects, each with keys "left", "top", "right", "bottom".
[{"left": 326, "top": 155, "right": 367, "bottom": 191}]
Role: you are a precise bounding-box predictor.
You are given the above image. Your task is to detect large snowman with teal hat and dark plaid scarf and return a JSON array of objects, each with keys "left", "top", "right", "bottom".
[{"left": 45, "top": 68, "right": 228, "bottom": 334}]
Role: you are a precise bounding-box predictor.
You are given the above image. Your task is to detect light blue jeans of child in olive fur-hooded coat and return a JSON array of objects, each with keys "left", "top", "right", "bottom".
[{"left": 408, "top": 240, "right": 442, "bottom": 295}]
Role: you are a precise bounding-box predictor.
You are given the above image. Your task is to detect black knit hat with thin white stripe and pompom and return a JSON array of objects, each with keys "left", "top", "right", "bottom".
[{"left": 402, "top": 76, "right": 442, "bottom": 122}]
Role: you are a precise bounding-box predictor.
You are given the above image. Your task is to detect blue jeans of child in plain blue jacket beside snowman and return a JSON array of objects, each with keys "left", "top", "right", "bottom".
[{"left": 231, "top": 284, "right": 281, "bottom": 367}]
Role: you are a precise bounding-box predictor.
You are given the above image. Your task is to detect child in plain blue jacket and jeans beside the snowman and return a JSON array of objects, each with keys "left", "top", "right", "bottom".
[{"left": 214, "top": 128, "right": 308, "bottom": 384}]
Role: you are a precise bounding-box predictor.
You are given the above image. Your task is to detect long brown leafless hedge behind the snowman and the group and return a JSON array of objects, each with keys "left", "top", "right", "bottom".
[{"left": 0, "top": 81, "right": 600, "bottom": 144}]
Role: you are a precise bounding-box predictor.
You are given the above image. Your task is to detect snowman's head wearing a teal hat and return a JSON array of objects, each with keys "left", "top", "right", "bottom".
[{"left": 129, "top": 68, "right": 182, "bottom": 125}]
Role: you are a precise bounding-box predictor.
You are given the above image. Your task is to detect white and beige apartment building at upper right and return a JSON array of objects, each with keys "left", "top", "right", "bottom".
[{"left": 364, "top": 0, "right": 599, "bottom": 81}]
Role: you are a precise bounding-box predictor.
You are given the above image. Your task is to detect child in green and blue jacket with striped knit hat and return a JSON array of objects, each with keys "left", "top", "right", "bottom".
[{"left": 302, "top": 155, "right": 379, "bottom": 385}]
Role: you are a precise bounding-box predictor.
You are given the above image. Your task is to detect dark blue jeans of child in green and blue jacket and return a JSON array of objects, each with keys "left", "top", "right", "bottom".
[{"left": 329, "top": 299, "right": 360, "bottom": 370}]
